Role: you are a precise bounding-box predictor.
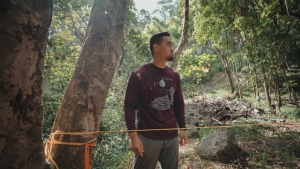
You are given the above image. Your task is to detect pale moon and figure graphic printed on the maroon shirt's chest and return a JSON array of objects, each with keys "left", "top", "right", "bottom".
[{"left": 150, "top": 78, "right": 175, "bottom": 110}]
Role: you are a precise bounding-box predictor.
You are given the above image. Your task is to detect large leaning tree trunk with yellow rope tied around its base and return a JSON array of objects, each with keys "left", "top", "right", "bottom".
[{"left": 48, "top": 0, "right": 129, "bottom": 169}]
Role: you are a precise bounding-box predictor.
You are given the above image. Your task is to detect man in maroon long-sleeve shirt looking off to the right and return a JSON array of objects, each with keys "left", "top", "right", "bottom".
[{"left": 124, "top": 32, "right": 188, "bottom": 169}]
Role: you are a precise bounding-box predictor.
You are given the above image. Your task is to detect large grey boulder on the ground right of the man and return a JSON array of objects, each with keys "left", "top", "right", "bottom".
[{"left": 198, "top": 131, "right": 245, "bottom": 163}]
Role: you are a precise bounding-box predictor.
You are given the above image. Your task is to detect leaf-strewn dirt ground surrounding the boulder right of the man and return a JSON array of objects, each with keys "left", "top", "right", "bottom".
[{"left": 179, "top": 124, "right": 300, "bottom": 169}]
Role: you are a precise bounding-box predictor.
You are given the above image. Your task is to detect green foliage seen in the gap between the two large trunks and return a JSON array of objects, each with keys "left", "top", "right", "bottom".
[{"left": 43, "top": 1, "right": 83, "bottom": 141}]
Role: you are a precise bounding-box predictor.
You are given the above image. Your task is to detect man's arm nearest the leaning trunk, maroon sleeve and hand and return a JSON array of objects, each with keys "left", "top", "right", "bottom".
[{"left": 124, "top": 73, "right": 144, "bottom": 156}]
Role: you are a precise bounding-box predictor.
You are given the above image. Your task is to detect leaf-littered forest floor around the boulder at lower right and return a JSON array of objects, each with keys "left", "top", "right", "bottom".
[{"left": 179, "top": 125, "right": 300, "bottom": 169}]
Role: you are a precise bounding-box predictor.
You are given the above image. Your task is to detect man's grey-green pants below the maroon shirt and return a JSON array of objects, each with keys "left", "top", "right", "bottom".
[{"left": 134, "top": 135, "right": 179, "bottom": 169}]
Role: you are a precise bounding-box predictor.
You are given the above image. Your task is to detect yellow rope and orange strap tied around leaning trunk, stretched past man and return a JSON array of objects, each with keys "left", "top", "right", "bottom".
[{"left": 45, "top": 122, "right": 300, "bottom": 169}]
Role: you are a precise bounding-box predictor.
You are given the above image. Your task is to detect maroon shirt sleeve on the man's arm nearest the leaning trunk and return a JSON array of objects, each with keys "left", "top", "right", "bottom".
[{"left": 124, "top": 72, "right": 141, "bottom": 130}]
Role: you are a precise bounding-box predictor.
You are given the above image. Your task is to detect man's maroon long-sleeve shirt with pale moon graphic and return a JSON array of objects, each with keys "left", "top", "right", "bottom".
[{"left": 124, "top": 63, "right": 185, "bottom": 140}]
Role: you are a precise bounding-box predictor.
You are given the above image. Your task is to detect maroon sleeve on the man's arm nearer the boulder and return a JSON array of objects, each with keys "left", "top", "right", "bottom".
[{"left": 174, "top": 73, "right": 186, "bottom": 128}]
